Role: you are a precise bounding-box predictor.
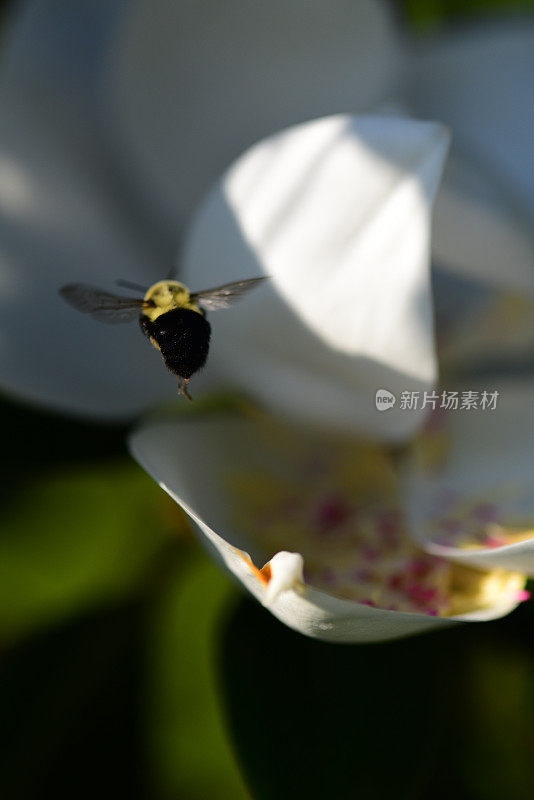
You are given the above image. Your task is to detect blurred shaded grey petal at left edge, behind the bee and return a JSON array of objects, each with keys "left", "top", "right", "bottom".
[{"left": 0, "top": 83, "right": 174, "bottom": 417}]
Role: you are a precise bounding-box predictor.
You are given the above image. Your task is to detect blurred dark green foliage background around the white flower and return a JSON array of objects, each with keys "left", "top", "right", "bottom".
[{"left": 0, "top": 0, "right": 534, "bottom": 800}]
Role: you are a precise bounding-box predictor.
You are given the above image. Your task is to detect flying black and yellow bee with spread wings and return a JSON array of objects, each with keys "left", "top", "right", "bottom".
[{"left": 59, "top": 277, "right": 266, "bottom": 400}]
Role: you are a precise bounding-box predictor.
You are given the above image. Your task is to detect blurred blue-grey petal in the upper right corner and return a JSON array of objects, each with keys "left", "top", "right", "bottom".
[{"left": 411, "top": 21, "right": 534, "bottom": 219}]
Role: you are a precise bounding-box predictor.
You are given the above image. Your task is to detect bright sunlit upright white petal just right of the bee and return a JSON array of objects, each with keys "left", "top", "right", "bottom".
[{"left": 183, "top": 115, "right": 448, "bottom": 438}]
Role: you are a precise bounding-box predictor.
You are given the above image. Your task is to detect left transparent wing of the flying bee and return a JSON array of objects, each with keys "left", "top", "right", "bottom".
[{"left": 59, "top": 283, "right": 146, "bottom": 325}]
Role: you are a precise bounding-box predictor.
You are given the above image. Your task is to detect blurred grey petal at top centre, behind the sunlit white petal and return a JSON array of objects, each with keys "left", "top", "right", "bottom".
[{"left": 109, "top": 0, "right": 401, "bottom": 230}]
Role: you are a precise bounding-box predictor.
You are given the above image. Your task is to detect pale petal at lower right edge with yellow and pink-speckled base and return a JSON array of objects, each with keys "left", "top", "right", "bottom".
[{"left": 406, "top": 383, "right": 534, "bottom": 575}]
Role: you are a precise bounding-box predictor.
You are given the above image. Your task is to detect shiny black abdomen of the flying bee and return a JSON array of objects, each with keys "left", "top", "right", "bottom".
[{"left": 140, "top": 308, "right": 211, "bottom": 380}]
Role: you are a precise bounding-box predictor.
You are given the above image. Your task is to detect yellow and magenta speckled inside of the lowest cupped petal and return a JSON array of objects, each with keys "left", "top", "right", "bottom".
[{"left": 231, "top": 432, "right": 527, "bottom": 616}]
